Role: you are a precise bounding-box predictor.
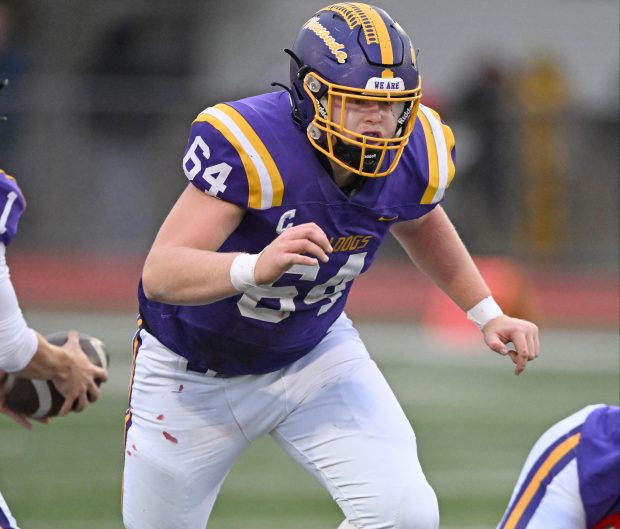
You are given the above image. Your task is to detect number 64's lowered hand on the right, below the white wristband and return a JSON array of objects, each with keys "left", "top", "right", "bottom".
[{"left": 482, "top": 314, "right": 540, "bottom": 375}]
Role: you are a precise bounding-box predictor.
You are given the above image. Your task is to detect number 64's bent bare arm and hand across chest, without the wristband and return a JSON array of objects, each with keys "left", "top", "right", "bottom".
[{"left": 142, "top": 185, "right": 331, "bottom": 305}]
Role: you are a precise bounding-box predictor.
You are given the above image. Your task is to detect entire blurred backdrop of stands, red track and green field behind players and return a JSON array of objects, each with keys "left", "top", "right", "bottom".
[{"left": 0, "top": 0, "right": 620, "bottom": 529}]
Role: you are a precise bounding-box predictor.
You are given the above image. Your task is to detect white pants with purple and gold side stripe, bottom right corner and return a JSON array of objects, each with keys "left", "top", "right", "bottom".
[{"left": 497, "top": 404, "right": 602, "bottom": 529}]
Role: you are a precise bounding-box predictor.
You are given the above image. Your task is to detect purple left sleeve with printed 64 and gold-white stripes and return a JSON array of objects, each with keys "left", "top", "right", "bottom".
[{"left": 183, "top": 104, "right": 282, "bottom": 209}]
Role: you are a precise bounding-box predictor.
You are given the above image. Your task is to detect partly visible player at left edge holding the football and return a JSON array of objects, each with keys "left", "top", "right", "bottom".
[{"left": 0, "top": 82, "right": 107, "bottom": 529}]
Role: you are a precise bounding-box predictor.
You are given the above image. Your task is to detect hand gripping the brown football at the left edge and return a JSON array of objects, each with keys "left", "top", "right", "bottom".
[{"left": 52, "top": 331, "right": 108, "bottom": 417}]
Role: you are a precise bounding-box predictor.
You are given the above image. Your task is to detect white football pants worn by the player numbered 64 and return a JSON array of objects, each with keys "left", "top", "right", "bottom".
[{"left": 123, "top": 315, "right": 439, "bottom": 529}]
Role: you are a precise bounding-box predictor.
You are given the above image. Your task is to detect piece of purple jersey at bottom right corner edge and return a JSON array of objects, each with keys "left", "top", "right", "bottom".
[{"left": 577, "top": 406, "right": 620, "bottom": 529}]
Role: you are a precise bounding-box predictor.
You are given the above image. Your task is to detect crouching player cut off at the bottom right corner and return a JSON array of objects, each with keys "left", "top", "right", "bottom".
[{"left": 497, "top": 404, "right": 620, "bottom": 529}]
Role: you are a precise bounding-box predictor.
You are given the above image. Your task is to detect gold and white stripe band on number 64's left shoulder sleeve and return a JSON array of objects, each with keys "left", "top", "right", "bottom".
[{"left": 195, "top": 104, "right": 284, "bottom": 209}]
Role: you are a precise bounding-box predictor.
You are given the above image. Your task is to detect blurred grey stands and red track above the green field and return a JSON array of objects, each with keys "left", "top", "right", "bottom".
[{"left": 0, "top": 0, "right": 619, "bottom": 325}]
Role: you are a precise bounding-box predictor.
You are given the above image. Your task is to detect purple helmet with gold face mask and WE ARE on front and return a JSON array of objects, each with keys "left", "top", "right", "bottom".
[{"left": 286, "top": 2, "right": 422, "bottom": 177}]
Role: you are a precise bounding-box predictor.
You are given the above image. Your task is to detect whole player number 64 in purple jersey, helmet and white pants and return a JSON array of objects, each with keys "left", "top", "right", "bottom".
[{"left": 123, "top": 2, "right": 539, "bottom": 529}]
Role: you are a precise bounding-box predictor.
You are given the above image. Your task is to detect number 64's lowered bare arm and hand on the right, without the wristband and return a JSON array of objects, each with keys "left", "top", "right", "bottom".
[{"left": 392, "top": 206, "right": 539, "bottom": 375}]
